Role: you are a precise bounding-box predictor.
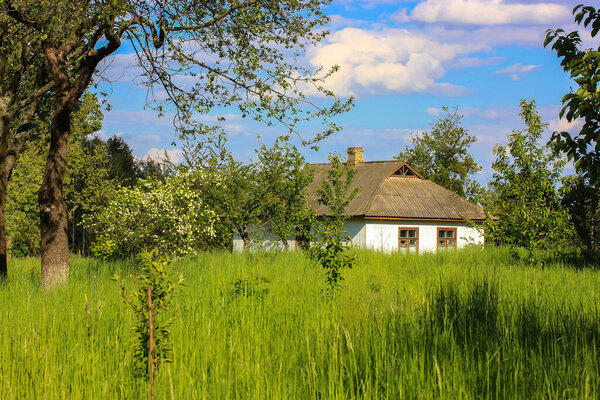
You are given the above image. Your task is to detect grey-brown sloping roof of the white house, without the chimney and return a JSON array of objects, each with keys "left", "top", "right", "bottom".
[{"left": 308, "top": 161, "right": 485, "bottom": 221}]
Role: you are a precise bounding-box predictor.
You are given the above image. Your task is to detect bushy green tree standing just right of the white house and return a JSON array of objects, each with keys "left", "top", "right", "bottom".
[{"left": 486, "top": 100, "right": 568, "bottom": 263}]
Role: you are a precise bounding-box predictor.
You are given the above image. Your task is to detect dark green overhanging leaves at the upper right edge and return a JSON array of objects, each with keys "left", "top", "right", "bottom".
[{"left": 544, "top": 4, "right": 600, "bottom": 184}]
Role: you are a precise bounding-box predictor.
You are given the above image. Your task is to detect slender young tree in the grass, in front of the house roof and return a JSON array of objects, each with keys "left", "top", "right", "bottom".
[{"left": 308, "top": 153, "right": 358, "bottom": 289}]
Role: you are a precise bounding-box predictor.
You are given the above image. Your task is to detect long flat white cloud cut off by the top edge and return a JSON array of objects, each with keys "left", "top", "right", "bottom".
[{"left": 410, "top": 0, "right": 571, "bottom": 25}]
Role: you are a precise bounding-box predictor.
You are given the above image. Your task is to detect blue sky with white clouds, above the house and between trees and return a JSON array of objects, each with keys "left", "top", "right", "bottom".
[{"left": 95, "top": 0, "right": 598, "bottom": 183}]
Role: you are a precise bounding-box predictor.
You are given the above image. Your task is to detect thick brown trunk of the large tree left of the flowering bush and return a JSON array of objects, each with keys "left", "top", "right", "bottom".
[{"left": 39, "top": 99, "right": 73, "bottom": 288}]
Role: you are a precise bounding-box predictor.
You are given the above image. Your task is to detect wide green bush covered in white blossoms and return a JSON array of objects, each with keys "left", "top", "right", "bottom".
[{"left": 84, "top": 170, "right": 219, "bottom": 258}]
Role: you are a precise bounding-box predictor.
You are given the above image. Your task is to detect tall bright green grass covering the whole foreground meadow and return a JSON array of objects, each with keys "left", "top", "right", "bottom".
[{"left": 0, "top": 249, "right": 600, "bottom": 399}]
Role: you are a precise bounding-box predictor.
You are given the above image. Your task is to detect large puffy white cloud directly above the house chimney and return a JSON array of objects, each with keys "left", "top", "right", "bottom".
[{"left": 310, "top": 28, "right": 466, "bottom": 96}]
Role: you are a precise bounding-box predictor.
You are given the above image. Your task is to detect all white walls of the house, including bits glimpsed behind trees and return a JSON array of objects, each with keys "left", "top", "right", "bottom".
[{"left": 233, "top": 218, "right": 483, "bottom": 252}]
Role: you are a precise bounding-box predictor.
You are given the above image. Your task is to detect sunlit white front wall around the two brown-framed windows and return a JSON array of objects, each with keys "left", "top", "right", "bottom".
[{"left": 364, "top": 220, "right": 483, "bottom": 252}]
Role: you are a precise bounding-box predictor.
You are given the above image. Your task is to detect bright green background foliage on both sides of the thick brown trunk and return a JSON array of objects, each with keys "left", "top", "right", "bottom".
[{"left": 6, "top": 93, "right": 115, "bottom": 256}]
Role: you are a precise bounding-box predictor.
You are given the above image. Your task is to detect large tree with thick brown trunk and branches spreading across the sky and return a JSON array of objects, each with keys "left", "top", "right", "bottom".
[{"left": 0, "top": 0, "right": 350, "bottom": 286}]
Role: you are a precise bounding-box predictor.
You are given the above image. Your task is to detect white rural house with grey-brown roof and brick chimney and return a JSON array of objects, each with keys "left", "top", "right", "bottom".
[{"left": 233, "top": 147, "right": 485, "bottom": 253}]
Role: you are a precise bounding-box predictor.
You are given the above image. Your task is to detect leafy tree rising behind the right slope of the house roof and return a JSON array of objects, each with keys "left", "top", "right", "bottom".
[{"left": 396, "top": 107, "right": 481, "bottom": 198}]
